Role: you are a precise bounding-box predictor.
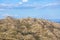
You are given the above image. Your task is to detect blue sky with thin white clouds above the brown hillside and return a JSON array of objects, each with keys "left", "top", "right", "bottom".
[{"left": 0, "top": 0, "right": 60, "bottom": 19}]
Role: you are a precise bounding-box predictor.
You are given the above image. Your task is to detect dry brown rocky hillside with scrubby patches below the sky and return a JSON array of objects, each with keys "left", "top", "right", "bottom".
[{"left": 0, "top": 17, "right": 60, "bottom": 40}]
